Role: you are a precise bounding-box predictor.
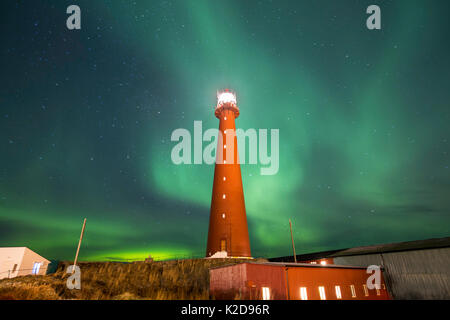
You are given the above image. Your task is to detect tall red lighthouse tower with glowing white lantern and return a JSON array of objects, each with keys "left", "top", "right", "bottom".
[{"left": 206, "top": 90, "right": 251, "bottom": 258}]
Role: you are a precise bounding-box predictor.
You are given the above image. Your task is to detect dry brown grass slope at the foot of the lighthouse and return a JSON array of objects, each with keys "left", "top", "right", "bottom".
[{"left": 0, "top": 259, "right": 264, "bottom": 300}]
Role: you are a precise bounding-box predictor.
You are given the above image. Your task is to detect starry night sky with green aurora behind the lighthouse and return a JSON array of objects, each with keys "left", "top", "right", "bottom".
[{"left": 0, "top": 0, "right": 450, "bottom": 260}]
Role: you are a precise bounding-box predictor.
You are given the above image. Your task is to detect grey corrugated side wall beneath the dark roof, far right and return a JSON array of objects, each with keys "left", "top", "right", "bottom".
[{"left": 334, "top": 248, "right": 450, "bottom": 299}]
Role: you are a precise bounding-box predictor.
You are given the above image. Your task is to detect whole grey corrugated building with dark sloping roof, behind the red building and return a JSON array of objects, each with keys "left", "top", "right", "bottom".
[{"left": 269, "top": 237, "right": 450, "bottom": 299}]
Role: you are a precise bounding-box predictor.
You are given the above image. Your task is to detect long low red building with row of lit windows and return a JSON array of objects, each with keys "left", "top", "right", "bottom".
[{"left": 210, "top": 262, "right": 390, "bottom": 300}]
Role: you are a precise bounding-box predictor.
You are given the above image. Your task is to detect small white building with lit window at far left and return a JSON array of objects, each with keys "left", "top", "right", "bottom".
[{"left": 0, "top": 247, "right": 50, "bottom": 279}]
